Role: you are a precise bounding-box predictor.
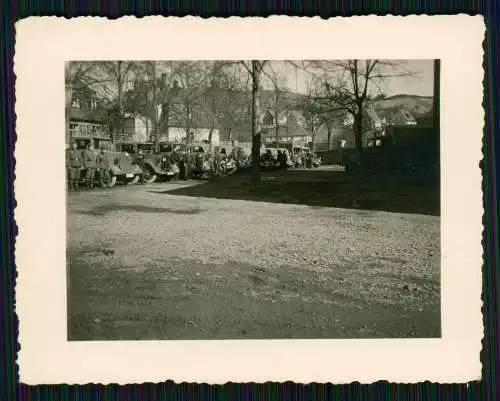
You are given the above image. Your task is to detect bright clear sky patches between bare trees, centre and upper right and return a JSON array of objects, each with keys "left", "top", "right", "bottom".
[{"left": 264, "top": 60, "right": 434, "bottom": 96}]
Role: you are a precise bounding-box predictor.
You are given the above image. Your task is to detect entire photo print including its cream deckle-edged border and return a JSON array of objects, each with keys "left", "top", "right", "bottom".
[{"left": 14, "top": 15, "right": 485, "bottom": 385}]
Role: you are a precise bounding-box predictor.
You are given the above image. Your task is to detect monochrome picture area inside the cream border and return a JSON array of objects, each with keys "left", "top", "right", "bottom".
[{"left": 65, "top": 59, "right": 441, "bottom": 341}]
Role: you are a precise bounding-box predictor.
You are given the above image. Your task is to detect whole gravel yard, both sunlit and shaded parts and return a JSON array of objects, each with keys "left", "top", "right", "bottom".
[{"left": 68, "top": 183, "right": 440, "bottom": 340}]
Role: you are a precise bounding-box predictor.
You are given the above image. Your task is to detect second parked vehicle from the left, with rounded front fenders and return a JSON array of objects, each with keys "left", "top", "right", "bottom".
[{"left": 117, "top": 142, "right": 185, "bottom": 184}]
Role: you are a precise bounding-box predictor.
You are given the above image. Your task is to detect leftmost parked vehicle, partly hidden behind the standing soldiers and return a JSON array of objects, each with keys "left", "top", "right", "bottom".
[{"left": 72, "top": 141, "right": 143, "bottom": 188}]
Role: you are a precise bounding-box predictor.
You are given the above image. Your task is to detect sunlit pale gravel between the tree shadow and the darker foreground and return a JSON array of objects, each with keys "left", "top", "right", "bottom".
[{"left": 68, "top": 183, "right": 440, "bottom": 337}]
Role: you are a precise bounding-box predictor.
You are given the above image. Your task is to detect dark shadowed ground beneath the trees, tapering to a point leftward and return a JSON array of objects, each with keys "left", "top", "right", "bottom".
[{"left": 156, "top": 170, "right": 440, "bottom": 216}]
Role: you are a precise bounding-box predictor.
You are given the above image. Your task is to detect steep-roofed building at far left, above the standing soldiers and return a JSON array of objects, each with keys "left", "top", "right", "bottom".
[{"left": 66, "top": 82, "right": 111, "bottom": 148}]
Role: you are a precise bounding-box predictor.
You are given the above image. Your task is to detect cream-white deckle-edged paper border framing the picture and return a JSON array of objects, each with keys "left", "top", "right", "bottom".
[{"left": 14, "top": 15, "right": 485, "bottom": 384}]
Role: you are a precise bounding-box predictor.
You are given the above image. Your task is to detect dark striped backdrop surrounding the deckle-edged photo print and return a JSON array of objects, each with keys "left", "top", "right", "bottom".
[{"left": 0, "top": 3, "right": 499, "bottom": 400}]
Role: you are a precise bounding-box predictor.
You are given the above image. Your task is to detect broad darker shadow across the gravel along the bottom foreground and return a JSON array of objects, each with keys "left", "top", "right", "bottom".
[{"left": 68, "top": 250, "right": 441, "bottom": 341}]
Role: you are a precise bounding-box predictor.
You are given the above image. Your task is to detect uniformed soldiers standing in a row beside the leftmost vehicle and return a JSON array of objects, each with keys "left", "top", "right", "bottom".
[{"left": 66, "top": 142, "right": 110, "bottom": 191}]
